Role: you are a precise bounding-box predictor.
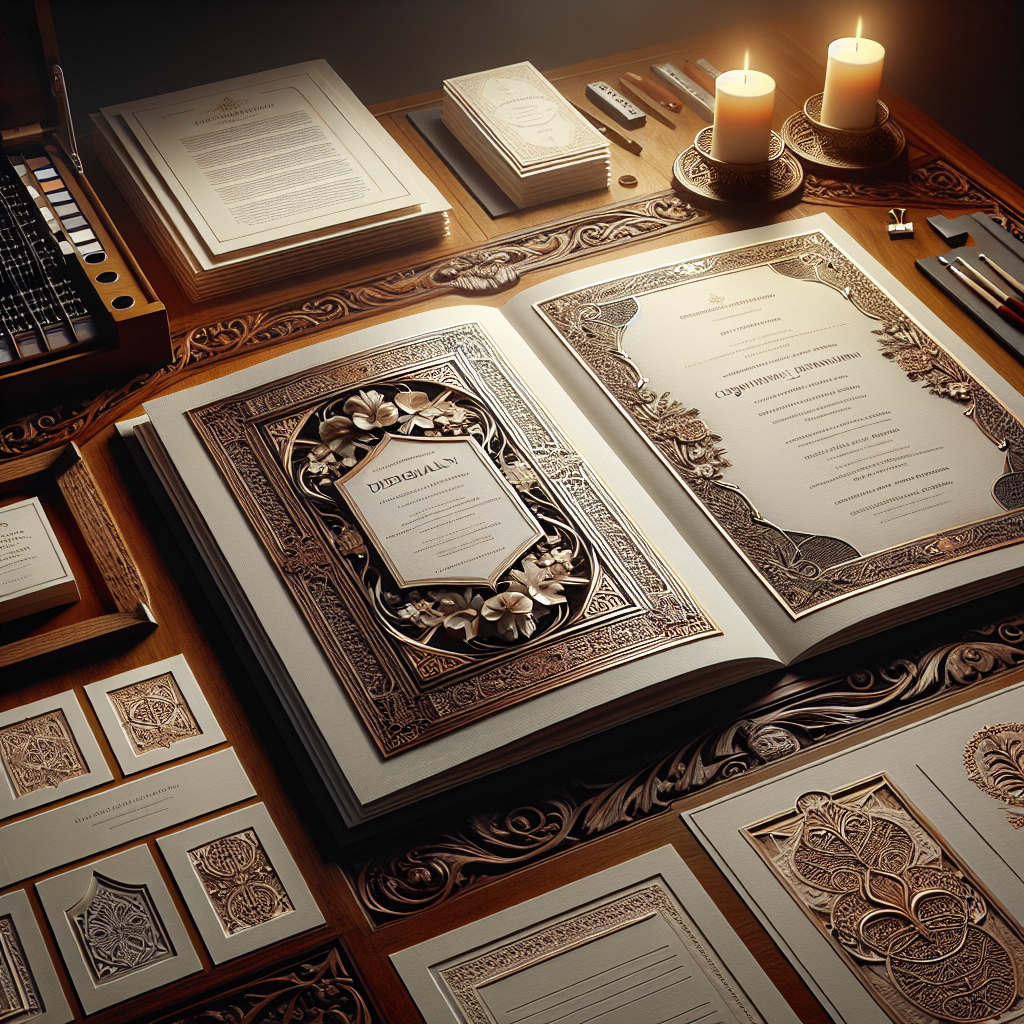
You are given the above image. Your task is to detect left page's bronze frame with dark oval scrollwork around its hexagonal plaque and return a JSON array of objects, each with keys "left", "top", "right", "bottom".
[{"left": 188, "top": 323, "right": 719, "bottom": 757}]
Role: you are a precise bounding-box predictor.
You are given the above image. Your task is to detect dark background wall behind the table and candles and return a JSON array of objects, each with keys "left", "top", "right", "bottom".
[{"left": 50, "top": 0, "right": 1024, "bottom": 184}]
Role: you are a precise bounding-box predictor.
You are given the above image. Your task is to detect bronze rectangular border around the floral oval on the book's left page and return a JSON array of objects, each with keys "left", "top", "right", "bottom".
[{"left": 188, "top": 323, "right": 721, "bottom": 757}]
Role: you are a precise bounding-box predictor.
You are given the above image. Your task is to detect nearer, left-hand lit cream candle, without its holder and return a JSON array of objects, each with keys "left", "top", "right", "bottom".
[{"left": 711, "top": 53, "right": 775, "bottom": 164}]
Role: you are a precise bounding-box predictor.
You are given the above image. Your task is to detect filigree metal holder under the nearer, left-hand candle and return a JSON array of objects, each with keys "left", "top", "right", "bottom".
[{"left": 672, "top": 125, "right": 804, "bottom": 204}]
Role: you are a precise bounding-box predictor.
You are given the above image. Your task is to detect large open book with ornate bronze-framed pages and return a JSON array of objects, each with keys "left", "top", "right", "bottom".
[{"left": 135, "top": 215, "right": 1024, "bottom": 824}]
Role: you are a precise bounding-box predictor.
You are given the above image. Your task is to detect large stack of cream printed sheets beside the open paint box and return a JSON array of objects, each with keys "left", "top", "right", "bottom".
[{"left": 92, "top": 60, "right": 450, "bottom": 301}]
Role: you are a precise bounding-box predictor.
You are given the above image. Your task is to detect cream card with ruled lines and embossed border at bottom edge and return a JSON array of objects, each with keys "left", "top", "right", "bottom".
[{"left": 391, "top": 847, "right": 798, "bottom": 1024}]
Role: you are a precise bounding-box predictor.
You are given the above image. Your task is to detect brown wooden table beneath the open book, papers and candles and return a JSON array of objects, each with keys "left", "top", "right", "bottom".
[{"left": 0, "top": 24, "right": 1024, "bottom": 1024}]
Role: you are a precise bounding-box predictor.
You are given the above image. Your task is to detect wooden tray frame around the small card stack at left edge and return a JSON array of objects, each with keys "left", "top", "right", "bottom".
[{"left": 0, "top": 443, "right": 157, "bottom": 668}]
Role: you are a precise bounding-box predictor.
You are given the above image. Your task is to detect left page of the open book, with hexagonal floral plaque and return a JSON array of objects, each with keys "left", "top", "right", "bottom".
[{"left": 138, "top": 307, "right": 777, "bottom": 805}]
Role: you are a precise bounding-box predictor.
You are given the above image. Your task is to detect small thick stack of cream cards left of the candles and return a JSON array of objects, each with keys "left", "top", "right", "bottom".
[{"left": 442, "top": 61, "right": 610, "bottom": 207}]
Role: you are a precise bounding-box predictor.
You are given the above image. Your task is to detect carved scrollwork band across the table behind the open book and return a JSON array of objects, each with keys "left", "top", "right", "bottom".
[{"left": 0, "top": 156, "right": 1024, "bottom": 459}]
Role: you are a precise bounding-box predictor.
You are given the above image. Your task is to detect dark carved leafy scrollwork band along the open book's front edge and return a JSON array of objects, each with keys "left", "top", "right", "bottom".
[{"left": 354, "top": 591, "right": 1024, "bottom": 923}]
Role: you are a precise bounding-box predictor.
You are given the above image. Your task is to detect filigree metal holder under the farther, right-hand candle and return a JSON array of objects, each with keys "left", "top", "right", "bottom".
[{"left": 782, "top": 92, "right": 906, "bottom": 171}]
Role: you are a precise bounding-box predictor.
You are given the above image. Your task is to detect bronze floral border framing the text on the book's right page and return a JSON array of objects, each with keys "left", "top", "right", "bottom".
[{"left": 535, "top": 231, "right": 1024, "bottom": 620}]
